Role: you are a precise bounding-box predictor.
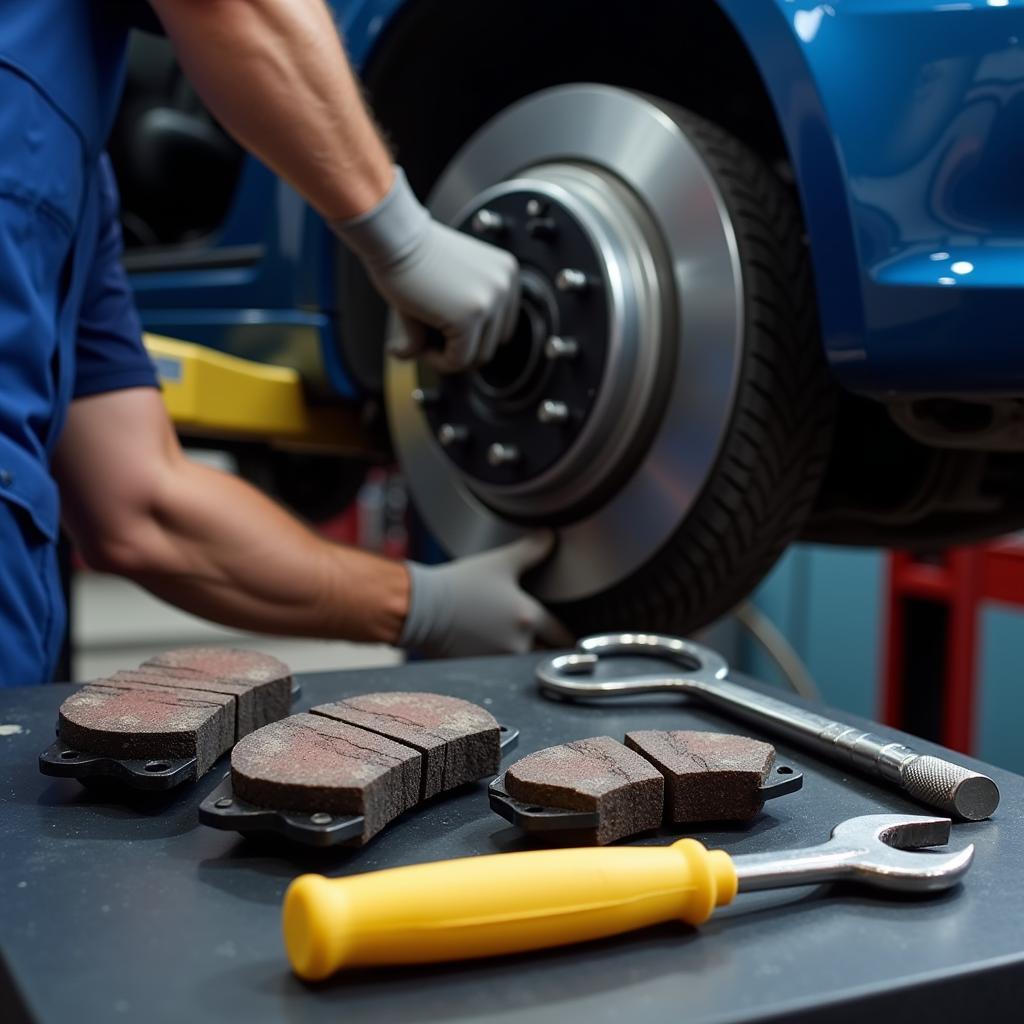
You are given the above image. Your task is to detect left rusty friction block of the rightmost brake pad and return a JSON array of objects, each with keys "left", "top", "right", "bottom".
[{"left": 505, "top": 736, "right": 665, "bottom": 844}]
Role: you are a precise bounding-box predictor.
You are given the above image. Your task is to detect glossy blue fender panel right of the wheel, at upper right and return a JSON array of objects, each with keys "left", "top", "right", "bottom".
[{"left": 719, "top": 0, "right": 1024, "bottom": 393}]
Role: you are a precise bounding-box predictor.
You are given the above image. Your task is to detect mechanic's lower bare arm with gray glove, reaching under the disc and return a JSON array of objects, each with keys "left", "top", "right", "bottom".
[{"left": 53, "top": 388, "right": 569, "bottom": 655}]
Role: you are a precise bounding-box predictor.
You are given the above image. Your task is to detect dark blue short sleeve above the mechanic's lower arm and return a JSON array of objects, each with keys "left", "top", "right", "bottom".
[{"left": 74, "top": 154, "right": 160, "bottom": 398}]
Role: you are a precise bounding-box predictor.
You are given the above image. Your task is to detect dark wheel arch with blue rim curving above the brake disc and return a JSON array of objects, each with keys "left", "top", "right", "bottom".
[{"left": 338, "top": 0, "right": 863, "bottom": 391}]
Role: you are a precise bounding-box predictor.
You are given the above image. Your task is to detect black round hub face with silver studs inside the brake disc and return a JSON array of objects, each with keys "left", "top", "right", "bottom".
[{"left": 420, "top": 183, "right": 610, "bottom": 488}]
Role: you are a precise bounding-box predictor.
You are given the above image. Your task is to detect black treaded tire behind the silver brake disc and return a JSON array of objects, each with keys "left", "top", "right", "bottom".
[{"left": 556, "top": 105, "right": 837, "bottom": 633}]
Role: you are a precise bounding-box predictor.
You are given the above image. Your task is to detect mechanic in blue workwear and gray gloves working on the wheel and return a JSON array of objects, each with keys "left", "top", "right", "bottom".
[{"left": 0, "top": 0, "right": 568, "bottom": 684}]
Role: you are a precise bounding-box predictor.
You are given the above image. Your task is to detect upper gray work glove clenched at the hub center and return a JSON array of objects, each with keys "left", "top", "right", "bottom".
[{"left": 331, "top": 167, "right": 519, "bottom": 373}]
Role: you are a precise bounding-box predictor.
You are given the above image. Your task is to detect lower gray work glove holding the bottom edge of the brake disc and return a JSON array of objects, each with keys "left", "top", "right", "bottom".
[{"left": 398, "top": 534, "right": 573, "bottom": 657}]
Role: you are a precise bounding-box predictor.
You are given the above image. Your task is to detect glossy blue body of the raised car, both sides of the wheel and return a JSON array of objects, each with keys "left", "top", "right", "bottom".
[{"left": 125, "top": 0, "right": 1024, "bottom": 398}]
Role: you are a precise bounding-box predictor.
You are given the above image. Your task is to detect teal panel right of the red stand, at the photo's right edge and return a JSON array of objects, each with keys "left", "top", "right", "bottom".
[{"left": 976, "top": 607, "right": 1024, "bottom": 772}]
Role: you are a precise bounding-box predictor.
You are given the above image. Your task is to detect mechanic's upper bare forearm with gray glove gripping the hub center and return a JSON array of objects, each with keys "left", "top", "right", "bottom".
[{"left": 151, "top": 0, "right": 519, "bottom": 371}]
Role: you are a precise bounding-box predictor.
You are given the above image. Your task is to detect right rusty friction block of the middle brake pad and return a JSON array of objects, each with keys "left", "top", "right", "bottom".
[{"left": 312, "top": 692, "right": 502, "bottom": 800}]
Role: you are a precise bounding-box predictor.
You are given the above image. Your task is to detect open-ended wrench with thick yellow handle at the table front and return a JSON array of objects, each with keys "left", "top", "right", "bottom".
[{"left": 284, "top": 814, "right": 974, "bottom": 981}]
